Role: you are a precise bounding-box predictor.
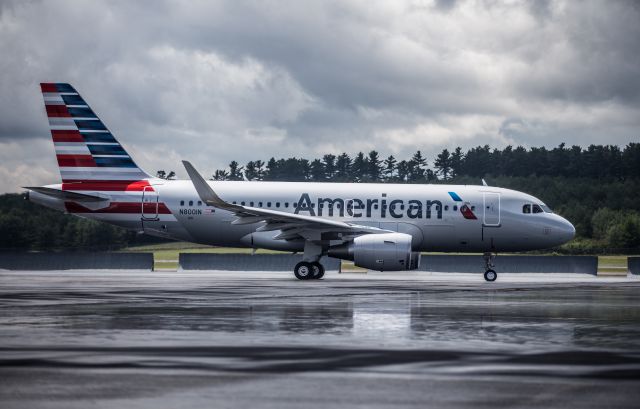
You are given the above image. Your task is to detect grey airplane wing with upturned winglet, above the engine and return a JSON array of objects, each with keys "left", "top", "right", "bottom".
[{"left": 182, "top": 161, "right": 390, "bottom": 240}]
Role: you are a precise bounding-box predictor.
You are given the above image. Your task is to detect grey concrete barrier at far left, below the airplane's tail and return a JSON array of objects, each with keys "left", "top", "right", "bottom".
[{"left": 0, "top": 252, "right": 153, "bottom": 270}]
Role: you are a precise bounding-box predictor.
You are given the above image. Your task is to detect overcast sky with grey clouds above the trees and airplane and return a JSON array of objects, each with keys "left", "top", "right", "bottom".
[{"left": 0, "top": 0, "right": 640, "bottom": 192}]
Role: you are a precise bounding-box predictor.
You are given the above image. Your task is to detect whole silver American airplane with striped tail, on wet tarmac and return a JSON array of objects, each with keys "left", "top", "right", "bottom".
[{"left": 25, "top": 83, "right": 575, "bottom": 281}]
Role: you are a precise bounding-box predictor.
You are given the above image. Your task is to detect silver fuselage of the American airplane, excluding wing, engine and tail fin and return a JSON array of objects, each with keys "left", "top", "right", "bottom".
[{"left": 30, "top": 179, "right": 575, "bottom": 252}]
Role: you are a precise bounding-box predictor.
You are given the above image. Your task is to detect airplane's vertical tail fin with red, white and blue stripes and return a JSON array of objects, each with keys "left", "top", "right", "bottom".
[{"left": 40, "top": 83, "right": 150, "bottom": 183}]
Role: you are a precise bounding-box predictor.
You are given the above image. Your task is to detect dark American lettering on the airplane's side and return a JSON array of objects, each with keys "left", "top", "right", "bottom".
[{"left": 294, "top": 193, "right": 442, "bottom": 219}]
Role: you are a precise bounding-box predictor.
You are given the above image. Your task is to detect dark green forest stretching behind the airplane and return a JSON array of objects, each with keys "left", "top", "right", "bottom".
[{"left": 0, "top": 143, "right": 640, "bottom": 253}]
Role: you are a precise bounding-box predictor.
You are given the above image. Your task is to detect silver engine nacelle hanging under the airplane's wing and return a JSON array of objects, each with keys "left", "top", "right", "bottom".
[{"left": 328, "top": 233, "right": 420, "bottom": 271}]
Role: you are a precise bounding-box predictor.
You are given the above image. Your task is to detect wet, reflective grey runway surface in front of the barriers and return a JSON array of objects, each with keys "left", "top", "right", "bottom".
[{"left": 0, "top": 271, "right": 640, "bottom": 409}]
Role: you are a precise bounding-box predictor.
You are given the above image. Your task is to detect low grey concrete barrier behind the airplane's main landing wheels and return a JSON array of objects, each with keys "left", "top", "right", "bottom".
[{"left": 179, "top": 253, "right": 340, "bottom": 271}]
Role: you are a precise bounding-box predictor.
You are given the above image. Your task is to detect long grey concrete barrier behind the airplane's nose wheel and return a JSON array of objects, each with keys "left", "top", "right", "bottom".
[{"left": 420, "top": 255, "right": 598, "bottom": 275}]
